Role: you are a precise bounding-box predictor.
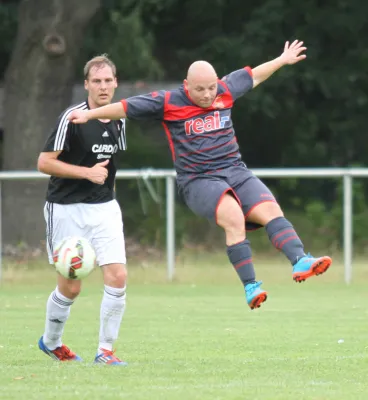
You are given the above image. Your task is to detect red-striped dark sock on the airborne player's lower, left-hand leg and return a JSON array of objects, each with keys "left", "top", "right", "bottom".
[{"left": 227, "top": 240, "right": 256, "bottom": 286}]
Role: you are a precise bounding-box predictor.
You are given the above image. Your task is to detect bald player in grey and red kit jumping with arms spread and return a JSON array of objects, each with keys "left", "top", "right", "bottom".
[{"left": 69, "top": 40, "right": 332, "bottom": 309}]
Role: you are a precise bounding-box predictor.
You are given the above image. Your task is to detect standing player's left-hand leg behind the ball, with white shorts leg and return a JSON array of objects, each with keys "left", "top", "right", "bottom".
[{"left": 38, "top": 203, "right": 83, "bottom": 361}]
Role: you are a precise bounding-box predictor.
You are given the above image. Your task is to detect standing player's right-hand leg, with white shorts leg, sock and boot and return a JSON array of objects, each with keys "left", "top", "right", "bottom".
[{"left": 90, "top": 200, "right": 127, "bottom": 366}]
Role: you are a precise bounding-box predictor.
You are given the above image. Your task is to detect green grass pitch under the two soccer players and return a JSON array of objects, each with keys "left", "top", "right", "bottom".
[{"left": 0, "top": 255, "right": 368, "bottom": 400}]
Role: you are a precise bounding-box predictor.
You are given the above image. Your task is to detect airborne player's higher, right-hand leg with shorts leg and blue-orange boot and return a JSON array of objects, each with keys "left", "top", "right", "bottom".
[{"left": 233, "top": 165, "right": 332, "bottom": 282}]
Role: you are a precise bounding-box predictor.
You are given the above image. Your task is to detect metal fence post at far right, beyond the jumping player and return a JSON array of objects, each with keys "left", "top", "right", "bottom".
[{"left": 343, "top": 173, "right": 353, "bottom": 284}]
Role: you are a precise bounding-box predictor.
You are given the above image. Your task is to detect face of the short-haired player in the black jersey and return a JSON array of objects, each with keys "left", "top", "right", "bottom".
[{"left": 84, "top": 64, "right": 118, "bottom": 108}]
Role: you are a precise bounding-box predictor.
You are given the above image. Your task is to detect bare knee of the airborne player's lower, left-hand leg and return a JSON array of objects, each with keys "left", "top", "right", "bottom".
[{"left": 216, "top": 194, "right": 245, "bottom": 246}]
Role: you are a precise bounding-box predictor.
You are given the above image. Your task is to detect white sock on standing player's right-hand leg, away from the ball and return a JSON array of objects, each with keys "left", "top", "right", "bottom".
[{"left": 97, "top": 285, "right": 126, "bottom": 354}]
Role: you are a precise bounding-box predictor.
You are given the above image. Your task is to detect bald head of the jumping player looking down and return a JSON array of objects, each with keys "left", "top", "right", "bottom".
[{"left": 184, "top": 61, "right": 217, "bottom": 108}]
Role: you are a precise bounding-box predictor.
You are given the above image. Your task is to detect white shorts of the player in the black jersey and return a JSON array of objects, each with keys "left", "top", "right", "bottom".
[{"left": 44, "top": 200, "right": 126, "bottom": 266}]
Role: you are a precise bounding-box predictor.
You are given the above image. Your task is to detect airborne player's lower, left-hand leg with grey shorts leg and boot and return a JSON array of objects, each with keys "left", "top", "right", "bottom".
[{"left": 181, "top": 177, "right": 267, "bottom": 309}]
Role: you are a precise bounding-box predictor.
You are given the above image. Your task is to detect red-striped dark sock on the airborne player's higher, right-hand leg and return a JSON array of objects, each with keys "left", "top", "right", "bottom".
[{"left": 266, "top": 217, "right": 305, "bottom": 265}]
